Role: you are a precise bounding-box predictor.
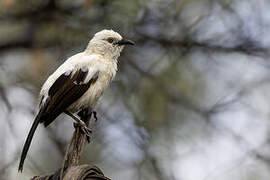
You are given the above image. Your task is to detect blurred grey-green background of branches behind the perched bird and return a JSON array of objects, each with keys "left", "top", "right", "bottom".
[{"left": 0, "top": 0, "right": 270, "bottom": 180}]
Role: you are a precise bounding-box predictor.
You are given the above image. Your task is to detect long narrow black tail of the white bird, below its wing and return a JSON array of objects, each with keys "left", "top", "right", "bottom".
[{"left": 18, "top": 113, "right": 40, "bottom": 172}]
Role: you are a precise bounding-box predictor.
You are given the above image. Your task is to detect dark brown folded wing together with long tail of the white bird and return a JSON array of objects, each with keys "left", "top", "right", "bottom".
[{"left": 19, "top": 68, "right": 98, "bottom": 171}]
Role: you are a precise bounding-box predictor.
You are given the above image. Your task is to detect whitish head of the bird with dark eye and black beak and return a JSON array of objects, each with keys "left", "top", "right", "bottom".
[{"left": 86, "top": 29, "right": 134, "bottom": 60}]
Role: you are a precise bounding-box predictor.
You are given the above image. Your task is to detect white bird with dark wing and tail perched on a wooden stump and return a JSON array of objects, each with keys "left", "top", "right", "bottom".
[{"left": 18, "top": 29, "right": 135, "bottom": 172}]
